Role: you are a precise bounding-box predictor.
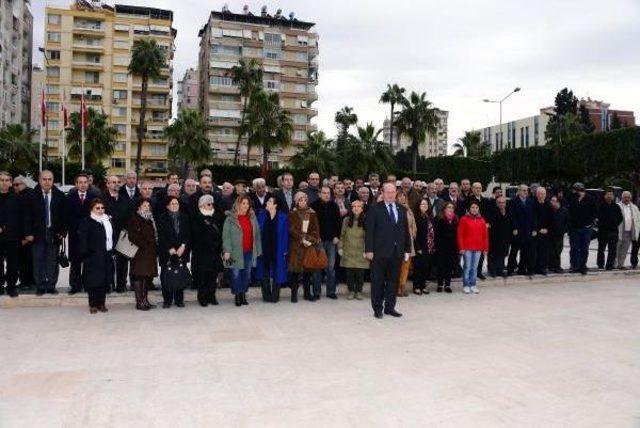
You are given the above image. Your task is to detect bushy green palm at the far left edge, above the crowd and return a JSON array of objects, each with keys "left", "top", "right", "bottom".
[{"left": 0, "top": 124, "right": 38, "bottom": 171}]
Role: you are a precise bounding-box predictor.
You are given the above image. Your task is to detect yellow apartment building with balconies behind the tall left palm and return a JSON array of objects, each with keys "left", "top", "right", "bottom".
[{"left": 42, "top": 0, "right": 176, "bottom": 178}]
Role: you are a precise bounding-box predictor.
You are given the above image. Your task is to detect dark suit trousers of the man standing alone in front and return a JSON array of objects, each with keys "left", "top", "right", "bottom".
[{"left": 371, "top": 256, "right": 402, "bottom": 312}]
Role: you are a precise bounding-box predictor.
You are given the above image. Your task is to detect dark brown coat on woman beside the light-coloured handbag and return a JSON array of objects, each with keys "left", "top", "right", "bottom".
[{"left": 127, "top": 213, "right": 158, "bottom": 278}]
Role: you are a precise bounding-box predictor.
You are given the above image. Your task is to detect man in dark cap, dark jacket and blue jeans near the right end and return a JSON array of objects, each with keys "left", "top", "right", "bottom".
[{"left": 569, "top": 183, "right": 596, "bottom": 275}]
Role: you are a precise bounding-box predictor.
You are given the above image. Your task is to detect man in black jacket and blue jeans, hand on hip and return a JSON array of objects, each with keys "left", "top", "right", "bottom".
[{"left": 311, "top": 186, "right": 342, "bottom": 300}]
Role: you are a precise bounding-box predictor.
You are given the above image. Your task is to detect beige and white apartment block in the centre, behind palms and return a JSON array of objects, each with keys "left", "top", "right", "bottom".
[{"left": 198, "top": 6, "right": 318, "bottom": 166}]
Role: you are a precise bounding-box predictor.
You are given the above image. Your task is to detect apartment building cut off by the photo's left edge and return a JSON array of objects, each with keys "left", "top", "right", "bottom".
[{"left": 0, "top": 0, "right": 33, "bottom": 127}]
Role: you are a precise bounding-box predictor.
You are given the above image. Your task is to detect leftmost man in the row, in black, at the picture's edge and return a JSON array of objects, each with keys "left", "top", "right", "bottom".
[{"left": 0, "top": 171, "right": 23, "bottom": 297}]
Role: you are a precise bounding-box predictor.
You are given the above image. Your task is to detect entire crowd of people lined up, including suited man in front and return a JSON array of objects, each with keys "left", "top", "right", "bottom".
[{"left": 0, "top": 170, "right": 640, "bottom": 318}]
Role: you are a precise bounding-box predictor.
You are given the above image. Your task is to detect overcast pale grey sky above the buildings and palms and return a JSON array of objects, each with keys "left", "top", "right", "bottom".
[{"left": 32, "top": 0, "right": 640, "bottom": 151}]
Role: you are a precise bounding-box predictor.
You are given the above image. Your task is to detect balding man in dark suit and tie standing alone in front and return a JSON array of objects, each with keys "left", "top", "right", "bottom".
[{"left": 365, "top": 183, "right": 411, "bottom": 318}]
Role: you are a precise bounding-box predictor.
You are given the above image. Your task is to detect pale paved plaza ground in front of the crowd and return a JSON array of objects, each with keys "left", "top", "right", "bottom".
[{"left": 0, "top": 273, "right": 640, "bottom": 427}]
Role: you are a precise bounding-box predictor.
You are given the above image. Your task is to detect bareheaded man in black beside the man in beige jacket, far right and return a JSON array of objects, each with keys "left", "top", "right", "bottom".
[{"left": 596, "top": 188, "right": 623, "bottom": 270}]
